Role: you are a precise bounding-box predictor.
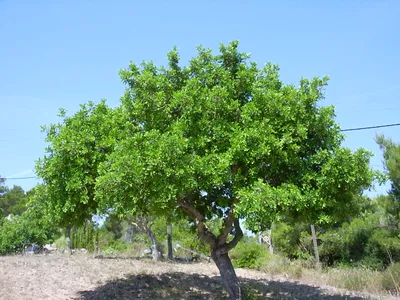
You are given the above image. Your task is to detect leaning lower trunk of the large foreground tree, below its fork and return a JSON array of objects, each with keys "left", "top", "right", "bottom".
[{"left": 211, "top": 250, "right": 242, "bottom": 300}]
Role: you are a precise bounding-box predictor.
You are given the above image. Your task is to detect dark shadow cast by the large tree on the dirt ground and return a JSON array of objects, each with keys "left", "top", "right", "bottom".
[{"left": 75, "top": 272, "right": 365, "bottom": 300}]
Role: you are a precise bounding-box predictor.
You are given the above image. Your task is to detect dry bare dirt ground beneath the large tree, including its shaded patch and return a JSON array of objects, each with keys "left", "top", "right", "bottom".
[{"left": 0, "top": 254, "right": 394, "bottom": 300}]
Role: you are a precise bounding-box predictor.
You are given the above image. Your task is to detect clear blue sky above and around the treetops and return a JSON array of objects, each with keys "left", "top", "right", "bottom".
[{"left": 0, "top": 0, "right": 400, "bottom": 197}]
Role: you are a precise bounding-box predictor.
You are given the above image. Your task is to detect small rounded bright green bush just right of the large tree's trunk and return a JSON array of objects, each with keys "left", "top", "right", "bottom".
[{"left": 230, "top": 241, "right": 269, "bottom": 269}]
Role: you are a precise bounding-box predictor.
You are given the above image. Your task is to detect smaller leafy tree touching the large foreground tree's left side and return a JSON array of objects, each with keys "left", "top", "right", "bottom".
[{"left": 36, "top": 101, "right": 128, "bottom": 250}]
